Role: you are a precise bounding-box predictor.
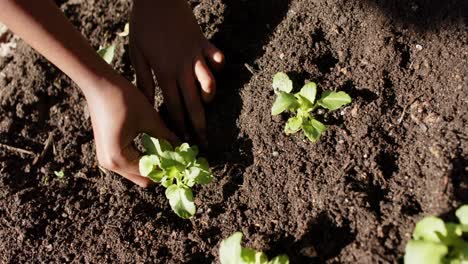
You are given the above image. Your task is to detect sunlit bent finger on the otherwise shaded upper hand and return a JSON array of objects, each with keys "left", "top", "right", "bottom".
[{"left": 194, "top": 57, "right": 216, "bottom": 103}]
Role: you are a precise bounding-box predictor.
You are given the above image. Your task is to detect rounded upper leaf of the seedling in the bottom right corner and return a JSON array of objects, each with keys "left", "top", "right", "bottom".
[{"left": 413, "top": 216, "right": 447, "bottom": 242}]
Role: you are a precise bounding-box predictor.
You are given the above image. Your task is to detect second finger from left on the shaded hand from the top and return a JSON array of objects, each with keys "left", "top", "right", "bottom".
[{"left": 158, "top": 78, "right": 189, "bottom": 140}]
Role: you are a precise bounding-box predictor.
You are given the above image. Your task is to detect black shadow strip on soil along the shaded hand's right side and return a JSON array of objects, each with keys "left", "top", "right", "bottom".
[{"left": 206, "top": 0, "right": 290, "bottom": 200}]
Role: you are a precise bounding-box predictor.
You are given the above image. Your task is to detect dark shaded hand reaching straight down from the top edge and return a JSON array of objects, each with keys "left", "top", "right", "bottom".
[{"left": 130, "top": 0, "right": 224, "bottom": 145}]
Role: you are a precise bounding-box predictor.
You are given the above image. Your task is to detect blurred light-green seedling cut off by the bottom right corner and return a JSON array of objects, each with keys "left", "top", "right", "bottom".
[{"left": 404, "top": 205, "right": 468, "bottom": 264}]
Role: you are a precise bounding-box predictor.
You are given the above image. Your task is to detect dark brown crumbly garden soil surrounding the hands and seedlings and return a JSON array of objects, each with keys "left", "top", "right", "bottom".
[{"left": 0, "top": 0, "right": 468, "bottom": 263}]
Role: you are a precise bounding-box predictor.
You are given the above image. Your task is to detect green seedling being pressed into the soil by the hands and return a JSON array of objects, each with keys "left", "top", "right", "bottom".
[{"left": 139, "top": 134, "right": 213, "bottom": 219}]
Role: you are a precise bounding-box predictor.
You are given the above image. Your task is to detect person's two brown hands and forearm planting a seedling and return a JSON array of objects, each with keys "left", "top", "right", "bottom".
[{"left": 0, "top": 0, "right": 224, "bottom": 187}]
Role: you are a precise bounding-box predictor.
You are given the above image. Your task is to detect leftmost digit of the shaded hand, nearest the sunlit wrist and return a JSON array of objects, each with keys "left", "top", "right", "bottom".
[{"left": 130, "top": 45, "right": 155, "bottom": 106}]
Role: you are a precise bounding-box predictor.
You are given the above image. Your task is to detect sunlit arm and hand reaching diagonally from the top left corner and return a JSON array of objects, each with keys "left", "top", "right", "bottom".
[{"left": 0, "top": 0, "right": 185, "bottom": 187}]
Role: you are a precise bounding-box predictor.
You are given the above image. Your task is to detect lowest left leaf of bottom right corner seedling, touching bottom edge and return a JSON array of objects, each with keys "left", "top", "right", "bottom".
[{"left": 404, "top": 240, "right": 448, "bottom": 264}]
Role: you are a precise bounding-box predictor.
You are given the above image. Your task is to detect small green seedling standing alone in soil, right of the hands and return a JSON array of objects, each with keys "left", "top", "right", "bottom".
[{"left": 271, "top": 72, "right": 351, "bottom": 142}]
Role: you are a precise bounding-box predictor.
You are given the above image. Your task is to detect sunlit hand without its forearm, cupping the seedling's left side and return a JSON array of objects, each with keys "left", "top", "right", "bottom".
[{"left": 86, "top": 74, "right": 179, "bottom": 187}]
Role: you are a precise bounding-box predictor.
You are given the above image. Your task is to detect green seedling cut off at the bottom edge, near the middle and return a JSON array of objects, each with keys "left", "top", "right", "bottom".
[{"left": 219, "top": 232, "right": 289, "bottom": 264}]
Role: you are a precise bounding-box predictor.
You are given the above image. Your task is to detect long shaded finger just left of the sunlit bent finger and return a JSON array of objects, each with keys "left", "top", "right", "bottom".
[{"left": 178, "top": 63, "right": 208, "bottom": 146}]
